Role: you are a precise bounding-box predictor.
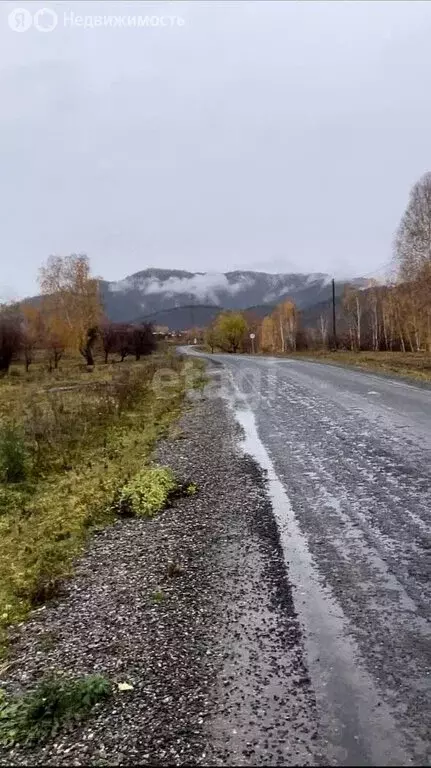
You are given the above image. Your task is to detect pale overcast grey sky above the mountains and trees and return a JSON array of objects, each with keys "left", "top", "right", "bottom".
[{"left": 0, "top": 0, "right": 431, "bottom": 296}]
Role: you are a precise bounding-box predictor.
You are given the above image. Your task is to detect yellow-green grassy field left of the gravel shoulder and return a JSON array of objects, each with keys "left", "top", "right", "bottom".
[{"left": 0, "top": 352, "right": 201, "bottom": 650}]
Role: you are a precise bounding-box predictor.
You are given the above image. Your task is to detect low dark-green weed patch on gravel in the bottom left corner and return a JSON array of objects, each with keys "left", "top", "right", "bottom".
[{"left": 0, "top": 675, "right": 111, "bottom": 747}]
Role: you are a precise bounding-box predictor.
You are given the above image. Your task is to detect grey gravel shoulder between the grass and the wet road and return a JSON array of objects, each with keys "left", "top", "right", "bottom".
[{"left": 0, "top": 376, "right": 320, "bottom": 765}]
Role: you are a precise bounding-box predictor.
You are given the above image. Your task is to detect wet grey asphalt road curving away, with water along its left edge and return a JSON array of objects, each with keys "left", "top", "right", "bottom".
[{"left": 185, "top": 355, "right": 431, "bottom": 765}]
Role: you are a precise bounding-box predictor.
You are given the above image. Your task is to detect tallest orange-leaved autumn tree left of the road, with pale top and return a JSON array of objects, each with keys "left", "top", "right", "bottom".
[{"left": 40, "top": 254, "right": 102, "bottom": 365}]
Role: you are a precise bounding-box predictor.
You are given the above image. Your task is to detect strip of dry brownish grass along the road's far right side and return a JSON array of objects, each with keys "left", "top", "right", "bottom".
[{"left": 288, "top": 350, "right": 431, "bottom": 382}]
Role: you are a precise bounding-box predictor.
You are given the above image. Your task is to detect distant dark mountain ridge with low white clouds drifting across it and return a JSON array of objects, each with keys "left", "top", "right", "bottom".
[{"left": 101, "top": 269, "right": 365, "bottom": 330}]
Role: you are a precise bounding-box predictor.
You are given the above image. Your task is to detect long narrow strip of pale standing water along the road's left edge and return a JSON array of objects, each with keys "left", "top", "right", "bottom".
[{"left": 228, "top": 400, "right": 411, "bottom": 766}]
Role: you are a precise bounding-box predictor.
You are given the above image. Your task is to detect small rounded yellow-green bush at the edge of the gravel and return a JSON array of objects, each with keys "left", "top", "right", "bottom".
[{"left": 118, "top": 467, "right": 177, "bottom": 517}]
